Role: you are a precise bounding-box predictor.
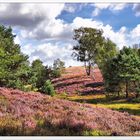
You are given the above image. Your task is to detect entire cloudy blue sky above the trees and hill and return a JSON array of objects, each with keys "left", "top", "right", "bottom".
[{"left": 0, "top": 3, "right": 140, "bottom": 66}]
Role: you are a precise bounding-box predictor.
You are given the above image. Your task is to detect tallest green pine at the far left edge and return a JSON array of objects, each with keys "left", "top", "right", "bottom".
[{"left": 0, "top": 25, "right": 28, "bottom": 89}]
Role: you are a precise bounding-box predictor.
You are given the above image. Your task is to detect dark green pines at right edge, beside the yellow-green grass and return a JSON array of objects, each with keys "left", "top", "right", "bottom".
[{"left": 103, "top": 47, "right": 140, "bottom": 98}]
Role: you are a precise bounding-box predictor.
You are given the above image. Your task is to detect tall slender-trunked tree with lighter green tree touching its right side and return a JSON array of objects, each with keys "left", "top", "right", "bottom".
[{"left": 72, "top": 27, "right": 117, "bottom": 75}]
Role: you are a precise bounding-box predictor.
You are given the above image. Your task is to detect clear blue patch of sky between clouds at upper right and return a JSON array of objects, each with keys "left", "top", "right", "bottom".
[{"left": 57, "top": 3, "right": 140, "bottom": 31}]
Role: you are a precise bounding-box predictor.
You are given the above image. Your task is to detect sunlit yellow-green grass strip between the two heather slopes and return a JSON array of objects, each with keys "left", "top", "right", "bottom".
[{"left": 67, "top": 94, "right": 140, "bottom": 116}]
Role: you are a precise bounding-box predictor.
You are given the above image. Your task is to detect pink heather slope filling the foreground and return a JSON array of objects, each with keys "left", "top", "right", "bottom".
[{"left": 0, "top": 88, "right": 140, "bottom": 136}]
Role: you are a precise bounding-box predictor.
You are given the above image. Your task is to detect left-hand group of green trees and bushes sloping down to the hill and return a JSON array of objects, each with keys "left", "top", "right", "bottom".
[{"left": 0, "top": 26, "right": 65, "bottom": 94}]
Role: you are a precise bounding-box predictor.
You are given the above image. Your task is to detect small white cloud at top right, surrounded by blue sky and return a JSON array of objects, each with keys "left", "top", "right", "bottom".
[{"left": 92, "top": 3, "right": 126, "bottom": 16}]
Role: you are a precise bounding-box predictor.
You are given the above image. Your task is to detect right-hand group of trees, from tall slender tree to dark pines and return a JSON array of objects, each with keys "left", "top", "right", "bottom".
[{"left": 72, "top": 27, "right": 140, "bottom": 98}]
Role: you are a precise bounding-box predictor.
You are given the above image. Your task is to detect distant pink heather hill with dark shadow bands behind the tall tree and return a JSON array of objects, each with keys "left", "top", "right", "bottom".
[{"left": 53, "top": 66, "right": 103, "bottom": 95}]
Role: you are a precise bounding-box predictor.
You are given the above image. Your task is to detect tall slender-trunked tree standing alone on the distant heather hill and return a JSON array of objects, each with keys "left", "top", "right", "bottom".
[{"left": 72, "top": 27, "right": 103, "bottom": 75}]
